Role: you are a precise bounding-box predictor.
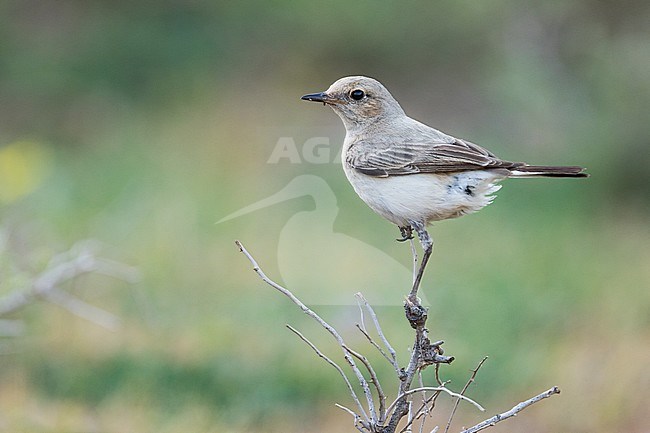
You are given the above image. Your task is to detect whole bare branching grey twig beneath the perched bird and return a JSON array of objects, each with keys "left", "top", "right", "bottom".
[{"left": 235, "top": 240, "right": 560, "bottom": 433}]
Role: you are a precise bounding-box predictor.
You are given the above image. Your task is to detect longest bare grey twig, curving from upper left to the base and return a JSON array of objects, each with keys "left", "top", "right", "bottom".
[{"left": 235, "top": 241, "right": 377, "bottom": 423}]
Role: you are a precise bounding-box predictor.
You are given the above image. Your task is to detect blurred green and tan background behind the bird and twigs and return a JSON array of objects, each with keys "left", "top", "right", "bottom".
[{"left": 0, "top": 0, "right": 650, "bottom": 433}]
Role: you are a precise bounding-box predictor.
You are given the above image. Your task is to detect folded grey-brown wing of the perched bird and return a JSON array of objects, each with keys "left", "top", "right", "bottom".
[{"left": 345, "top": 139, "right": 522, "bottom": 177}]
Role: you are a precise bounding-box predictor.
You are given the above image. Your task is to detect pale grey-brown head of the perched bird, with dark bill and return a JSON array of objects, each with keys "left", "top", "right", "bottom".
[{"left": 301, "top": 76, "right": 405, "bottom": 130}]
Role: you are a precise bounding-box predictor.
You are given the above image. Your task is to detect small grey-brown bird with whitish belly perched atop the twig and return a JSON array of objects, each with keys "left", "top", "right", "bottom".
[{"left": 301, "top": 76, "right": 588, "bottom": 302}]
